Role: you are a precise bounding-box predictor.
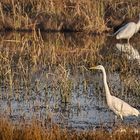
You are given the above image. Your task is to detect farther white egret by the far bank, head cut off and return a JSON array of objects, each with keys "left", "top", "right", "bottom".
[{"left": 113, "top": 14, "right": 140, "bottom": 42}]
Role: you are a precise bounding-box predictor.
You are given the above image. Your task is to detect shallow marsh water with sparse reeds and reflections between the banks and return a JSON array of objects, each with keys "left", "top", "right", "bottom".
[{"left": 0, "top": 33, "right": 140, "bottom": 129}]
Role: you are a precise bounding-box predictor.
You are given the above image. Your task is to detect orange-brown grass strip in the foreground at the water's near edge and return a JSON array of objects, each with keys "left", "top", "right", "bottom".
[{"left": 0, "top": 118, "right": 140, "bottom": 140}]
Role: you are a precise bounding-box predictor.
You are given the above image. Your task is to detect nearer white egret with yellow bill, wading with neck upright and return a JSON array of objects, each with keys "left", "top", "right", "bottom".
[{"left": 90, "top": 65, "right": 140, "bottom": 120}]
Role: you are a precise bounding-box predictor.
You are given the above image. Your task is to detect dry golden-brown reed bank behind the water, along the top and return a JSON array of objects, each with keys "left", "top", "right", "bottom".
[{"left": 0, "top": 0, "right": 140, "bottom": 33}]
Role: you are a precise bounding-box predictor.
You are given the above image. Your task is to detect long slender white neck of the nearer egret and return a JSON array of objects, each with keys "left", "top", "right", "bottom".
[{"left": 102, "top": 69, "right": 111, "bottom": 100}]
